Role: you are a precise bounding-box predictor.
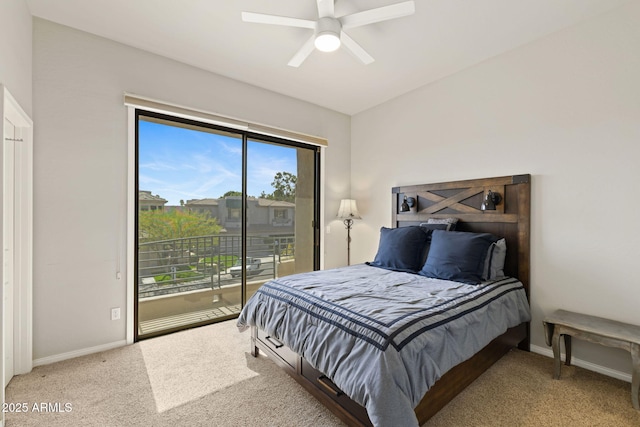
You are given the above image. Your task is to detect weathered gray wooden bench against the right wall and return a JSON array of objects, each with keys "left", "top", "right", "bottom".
[{"left": 543, "top": 310, "right": 640, "bottom": 410}]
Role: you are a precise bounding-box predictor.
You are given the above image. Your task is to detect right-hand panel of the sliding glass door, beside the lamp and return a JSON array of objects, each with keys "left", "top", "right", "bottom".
[{"left": 245, "top": 138, "right": 318, "bottom": 298}]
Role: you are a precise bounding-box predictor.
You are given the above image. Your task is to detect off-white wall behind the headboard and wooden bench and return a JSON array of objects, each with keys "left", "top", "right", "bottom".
[{"left": 351, "top": 2, "right": 640, "bottom": 373}]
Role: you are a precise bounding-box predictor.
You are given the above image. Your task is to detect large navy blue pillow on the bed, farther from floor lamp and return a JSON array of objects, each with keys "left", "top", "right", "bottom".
[{"left": 419, "top": 230, "right": 498, "bottom": 284}]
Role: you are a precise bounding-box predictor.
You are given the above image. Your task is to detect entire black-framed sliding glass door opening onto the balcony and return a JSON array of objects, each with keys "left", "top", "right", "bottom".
[{"left": 135, "top": 111, "right": 319, "bottom": 339}]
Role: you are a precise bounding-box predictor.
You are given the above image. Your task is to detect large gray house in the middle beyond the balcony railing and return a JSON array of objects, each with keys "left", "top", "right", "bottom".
[{"left": 185, "top": 196, "right": 296, "bottom": 234}]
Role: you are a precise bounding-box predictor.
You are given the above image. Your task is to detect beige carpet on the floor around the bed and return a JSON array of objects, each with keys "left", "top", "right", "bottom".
[{"left": 5, "top": 321, "right": 640, "bottom": 427}]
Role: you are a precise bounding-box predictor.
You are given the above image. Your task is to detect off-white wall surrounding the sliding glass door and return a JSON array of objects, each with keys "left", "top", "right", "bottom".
[{"left": 33, "top": 19, "right": 350, "bottom": 360}]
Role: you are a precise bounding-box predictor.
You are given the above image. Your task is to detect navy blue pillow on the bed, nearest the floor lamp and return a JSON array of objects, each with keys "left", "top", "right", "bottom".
[{"left": 367, "top": 226, "right": 431, "bottom": 273}]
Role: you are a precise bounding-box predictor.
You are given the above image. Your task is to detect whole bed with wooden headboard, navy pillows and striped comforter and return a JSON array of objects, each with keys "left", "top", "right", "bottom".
[{"left": 238, "top": 175, "right": 530, "bottom": 426}]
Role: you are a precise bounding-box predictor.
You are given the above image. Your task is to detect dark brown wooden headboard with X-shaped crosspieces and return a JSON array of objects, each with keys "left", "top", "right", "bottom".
[{"left": 391, "top": 174, "right": 531, "bottom": 297}]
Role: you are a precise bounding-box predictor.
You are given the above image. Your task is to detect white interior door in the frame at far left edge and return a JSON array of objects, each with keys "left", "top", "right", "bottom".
[{"left": 2, "top": 118, "right": 15, "bottom": 387}]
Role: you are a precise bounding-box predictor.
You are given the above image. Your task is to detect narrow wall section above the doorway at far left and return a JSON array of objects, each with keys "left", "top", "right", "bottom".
[{"left": 0, "top": 0, "right": 32, "bottom": 115}]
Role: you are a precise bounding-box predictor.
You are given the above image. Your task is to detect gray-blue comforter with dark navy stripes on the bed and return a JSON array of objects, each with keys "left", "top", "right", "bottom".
[{"left": 238, "top": 264, "right": 530, "bottom": 427}]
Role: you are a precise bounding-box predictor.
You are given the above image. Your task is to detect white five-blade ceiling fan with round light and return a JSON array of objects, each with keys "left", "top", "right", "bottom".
[{"left": 242, "top": 0, "right": 415, "bottom": 67}]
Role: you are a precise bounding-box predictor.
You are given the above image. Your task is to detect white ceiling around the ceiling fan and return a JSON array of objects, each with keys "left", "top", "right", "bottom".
[{"left": 27, "top": 0, "right": 636, "bottom": 115}]
